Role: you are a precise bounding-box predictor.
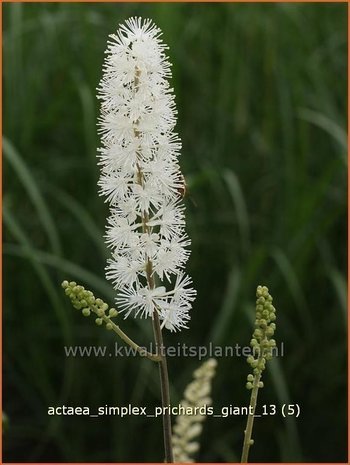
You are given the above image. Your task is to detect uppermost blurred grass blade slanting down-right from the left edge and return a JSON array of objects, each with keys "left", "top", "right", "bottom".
[{"left": 2, "top": 137, "right": 61, "bottom": 255}]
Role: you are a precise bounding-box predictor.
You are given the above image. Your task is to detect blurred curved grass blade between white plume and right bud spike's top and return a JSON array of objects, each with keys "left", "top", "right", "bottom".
[{"left": 223, "top": 169, "right": 250, "bottom": 252}]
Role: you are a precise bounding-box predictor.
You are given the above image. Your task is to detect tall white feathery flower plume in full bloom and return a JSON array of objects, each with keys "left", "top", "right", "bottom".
[{"left": 98, "top": 18, "right": 196, "bottom": 331}]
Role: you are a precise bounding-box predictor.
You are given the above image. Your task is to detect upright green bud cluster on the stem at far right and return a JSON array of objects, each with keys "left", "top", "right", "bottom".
[{"left": 246, "top": 286, "right": 276, "bottom": 389}]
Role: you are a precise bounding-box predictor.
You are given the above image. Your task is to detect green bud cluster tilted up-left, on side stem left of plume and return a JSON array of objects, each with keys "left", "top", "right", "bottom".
[{"left": 62, "top": 281, "right": 118, "bottom": 330}]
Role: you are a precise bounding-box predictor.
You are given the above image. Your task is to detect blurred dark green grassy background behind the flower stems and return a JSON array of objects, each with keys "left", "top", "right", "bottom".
[{"left": 3, "top": 3, "right": 347, "bottom": 462}]
